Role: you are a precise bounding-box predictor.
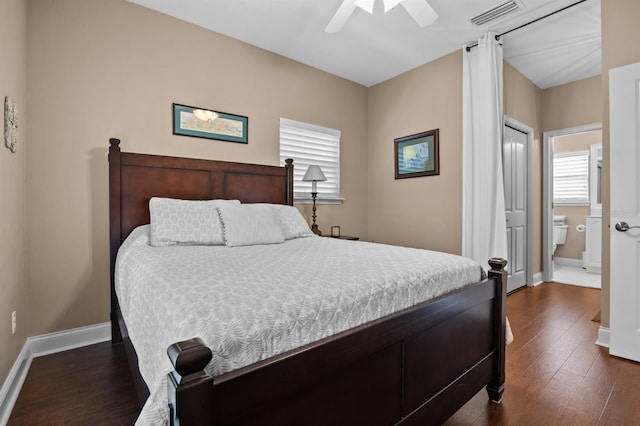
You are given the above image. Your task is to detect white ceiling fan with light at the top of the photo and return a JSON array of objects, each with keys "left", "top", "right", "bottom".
[{"left": 324, "top": 0, "right": 438, "bottom": 34}]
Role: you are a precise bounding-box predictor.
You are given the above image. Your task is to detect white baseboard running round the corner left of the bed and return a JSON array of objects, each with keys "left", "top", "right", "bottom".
[{"left": 0, "top": 322, "right": 111, "bottom": 425}]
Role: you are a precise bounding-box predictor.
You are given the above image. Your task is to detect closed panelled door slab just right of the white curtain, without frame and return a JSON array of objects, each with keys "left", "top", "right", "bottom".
[{"left": 502, "top": 125, "right": 528, "bottom": 292}]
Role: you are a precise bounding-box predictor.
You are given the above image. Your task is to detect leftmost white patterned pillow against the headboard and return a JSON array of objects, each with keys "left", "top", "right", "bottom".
[{"left": 149, "top": 197, "right": 240, "bottom": 247}]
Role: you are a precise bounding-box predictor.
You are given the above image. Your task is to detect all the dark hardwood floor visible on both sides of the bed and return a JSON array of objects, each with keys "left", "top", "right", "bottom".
[{"left": 9, "top": 283, "right": 640, "bottom": 426}]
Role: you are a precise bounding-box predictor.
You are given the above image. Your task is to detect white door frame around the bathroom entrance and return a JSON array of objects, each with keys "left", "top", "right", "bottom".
[{"left": 542, "top": 123, "right": 602, "bottom": 282}]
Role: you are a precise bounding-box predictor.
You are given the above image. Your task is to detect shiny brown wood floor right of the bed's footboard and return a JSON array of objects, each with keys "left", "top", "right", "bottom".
[{"left": 446, "top": 283, "right": 640, "bottom": 426}]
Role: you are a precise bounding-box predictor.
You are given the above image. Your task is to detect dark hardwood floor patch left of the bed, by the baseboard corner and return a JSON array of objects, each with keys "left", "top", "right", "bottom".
[{"left": 8, "top": 342, "right": 140, "bottom": 426}]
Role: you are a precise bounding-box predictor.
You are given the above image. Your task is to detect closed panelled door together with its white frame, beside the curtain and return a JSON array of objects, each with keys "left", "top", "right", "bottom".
[{"left": 502, "top": 117, "right": 533, "bottom": 292}]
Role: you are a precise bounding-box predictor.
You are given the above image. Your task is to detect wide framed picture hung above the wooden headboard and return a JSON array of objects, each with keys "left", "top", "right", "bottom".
[{"left": 173, "top": 104, "right": 249, "bottom": 143}]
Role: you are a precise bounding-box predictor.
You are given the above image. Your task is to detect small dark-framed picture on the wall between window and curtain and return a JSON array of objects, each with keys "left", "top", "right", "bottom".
[{"left": 394, "top": 129, "right": 440, "bottom": 179}]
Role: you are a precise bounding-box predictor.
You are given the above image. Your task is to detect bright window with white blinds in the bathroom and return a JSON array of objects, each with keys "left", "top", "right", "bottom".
[{"left": 553, "top": 151, "right": 589, "bottom": 205}]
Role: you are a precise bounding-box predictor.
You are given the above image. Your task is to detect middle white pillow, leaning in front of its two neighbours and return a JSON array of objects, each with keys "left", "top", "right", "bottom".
[{"left": 218, "top": 204, "right": 284, "bottom": 247}]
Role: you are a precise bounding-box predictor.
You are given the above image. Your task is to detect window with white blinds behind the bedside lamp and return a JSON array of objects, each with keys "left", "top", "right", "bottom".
[{"left": 280, "top": 118, "right": 342, "bottom": 203}]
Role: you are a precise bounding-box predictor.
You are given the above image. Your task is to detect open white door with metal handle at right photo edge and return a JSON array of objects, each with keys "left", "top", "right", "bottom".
[{"left": 609, "top": 63, "right": 640, "bottom": 361}]
